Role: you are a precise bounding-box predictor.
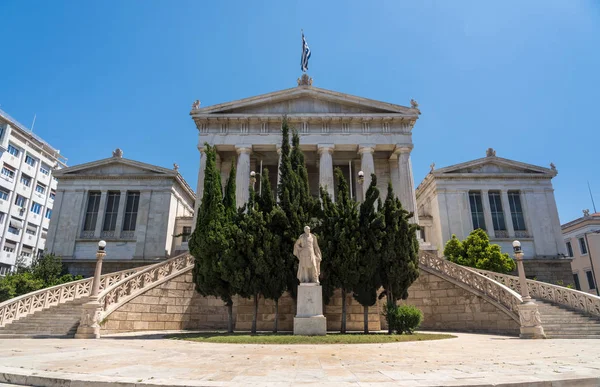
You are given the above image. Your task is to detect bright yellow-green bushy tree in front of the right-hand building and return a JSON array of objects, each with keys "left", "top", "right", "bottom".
[{"left": 444, "top": 228, "right": 516, "bottom": 274}]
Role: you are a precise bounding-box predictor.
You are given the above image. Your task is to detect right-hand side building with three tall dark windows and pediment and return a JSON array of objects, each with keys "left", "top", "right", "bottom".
[{"left": 416, "top": 148, "right": 573, "bottom": 284}]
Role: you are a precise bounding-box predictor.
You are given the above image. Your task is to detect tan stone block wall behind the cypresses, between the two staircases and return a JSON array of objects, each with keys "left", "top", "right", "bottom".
[{"left": 102, "top": 271, "right": 519, "bottom": 335}]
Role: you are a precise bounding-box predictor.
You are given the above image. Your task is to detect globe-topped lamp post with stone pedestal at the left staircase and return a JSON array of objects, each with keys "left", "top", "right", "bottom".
[{"left": 75, "top": 241, "right": 106, "bottom": 339}]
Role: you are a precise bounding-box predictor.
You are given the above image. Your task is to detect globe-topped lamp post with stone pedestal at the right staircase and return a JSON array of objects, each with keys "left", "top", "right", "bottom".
[{"left": 513, "top": 241, "right": 546, "bottom": 339}]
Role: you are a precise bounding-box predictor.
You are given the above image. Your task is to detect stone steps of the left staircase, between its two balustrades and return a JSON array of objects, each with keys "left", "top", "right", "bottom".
[{"left": 0, "top": 298, "right": 87, "bottom": 339}]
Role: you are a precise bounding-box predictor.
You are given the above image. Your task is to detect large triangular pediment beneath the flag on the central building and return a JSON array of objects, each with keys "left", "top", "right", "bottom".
[{"left": 191, "top": 86, "right": 419, "bottom": 117}]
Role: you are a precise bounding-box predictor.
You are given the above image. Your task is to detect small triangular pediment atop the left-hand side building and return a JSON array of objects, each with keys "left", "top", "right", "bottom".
[{"left": 55, "top": 157, "right": 177, "bottom": 177}]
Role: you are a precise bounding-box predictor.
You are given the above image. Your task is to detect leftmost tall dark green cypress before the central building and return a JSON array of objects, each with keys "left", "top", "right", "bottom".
[{"left": 189, "top": 143, "right": 234, "bottom": 332}]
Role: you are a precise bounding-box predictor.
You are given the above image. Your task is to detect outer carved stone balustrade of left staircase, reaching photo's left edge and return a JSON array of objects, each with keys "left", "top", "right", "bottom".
[{"left": 0, "top": 268, "right": 140, "bottom": 327}]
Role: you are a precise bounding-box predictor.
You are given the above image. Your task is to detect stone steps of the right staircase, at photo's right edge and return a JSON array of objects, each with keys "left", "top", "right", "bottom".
[{"left": 535, "top": 299, "right": 600, "bottom": 339}]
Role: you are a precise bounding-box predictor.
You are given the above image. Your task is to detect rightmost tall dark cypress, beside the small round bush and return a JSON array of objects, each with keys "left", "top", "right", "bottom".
[{"left": 380, "top": 182, "right": 419, "bottom": 334}]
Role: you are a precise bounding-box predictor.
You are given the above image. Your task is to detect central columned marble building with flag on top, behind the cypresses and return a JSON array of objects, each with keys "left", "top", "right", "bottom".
[{"left": 190, "top": 75, "right": 420, "bottom": 222}]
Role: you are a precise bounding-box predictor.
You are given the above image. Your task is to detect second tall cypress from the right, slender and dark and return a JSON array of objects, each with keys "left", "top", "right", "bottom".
[{"left": 353, "top": 174, "right": 385, "bottom": 333}]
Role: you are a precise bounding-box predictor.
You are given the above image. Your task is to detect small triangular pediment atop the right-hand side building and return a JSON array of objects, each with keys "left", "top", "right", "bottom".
[{"left": 433, "top": 156, "right": 556, "bottom": 177}]
